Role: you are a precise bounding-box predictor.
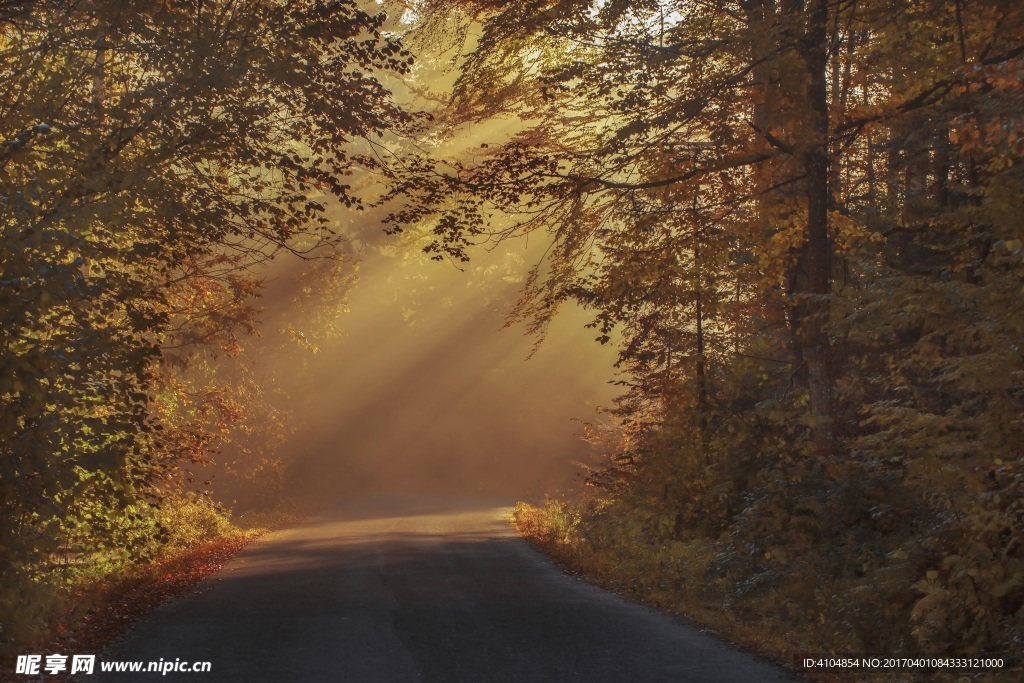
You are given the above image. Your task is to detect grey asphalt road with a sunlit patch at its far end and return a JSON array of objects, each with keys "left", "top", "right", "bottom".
[{"left": 94, "top": 496, "right": 793, "bottom": 683}]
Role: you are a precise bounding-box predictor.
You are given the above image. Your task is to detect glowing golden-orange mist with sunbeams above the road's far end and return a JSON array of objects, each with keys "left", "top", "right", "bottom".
[{"left": 214, "top": 219, "right": 617, "bottom": 505}]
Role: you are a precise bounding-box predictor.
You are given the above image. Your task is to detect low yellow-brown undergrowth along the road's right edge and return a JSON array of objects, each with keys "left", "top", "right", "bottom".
[{"left": 513, "top": 495, "right": 1022, "bottom": 683}]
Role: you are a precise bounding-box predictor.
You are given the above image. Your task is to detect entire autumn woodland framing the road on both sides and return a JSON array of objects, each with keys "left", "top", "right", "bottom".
[{"left": 0, "top": 0, "right": 1024, "bottom": 667}]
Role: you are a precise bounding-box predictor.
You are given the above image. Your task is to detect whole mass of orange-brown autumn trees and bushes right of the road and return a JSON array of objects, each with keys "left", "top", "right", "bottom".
[{"left": 392, "top": 0, "right": 1024, "bottom": 668}]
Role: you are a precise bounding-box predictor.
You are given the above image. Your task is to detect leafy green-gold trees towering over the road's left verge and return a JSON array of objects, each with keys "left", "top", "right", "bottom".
[{"left": 0, "top": 0, "right": 412, "bottom": 643}]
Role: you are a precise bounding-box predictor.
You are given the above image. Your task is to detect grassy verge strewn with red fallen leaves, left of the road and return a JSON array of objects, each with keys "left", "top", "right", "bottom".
[{"left": 0, "top": 497, "right": 305, "bottom": 683}]
